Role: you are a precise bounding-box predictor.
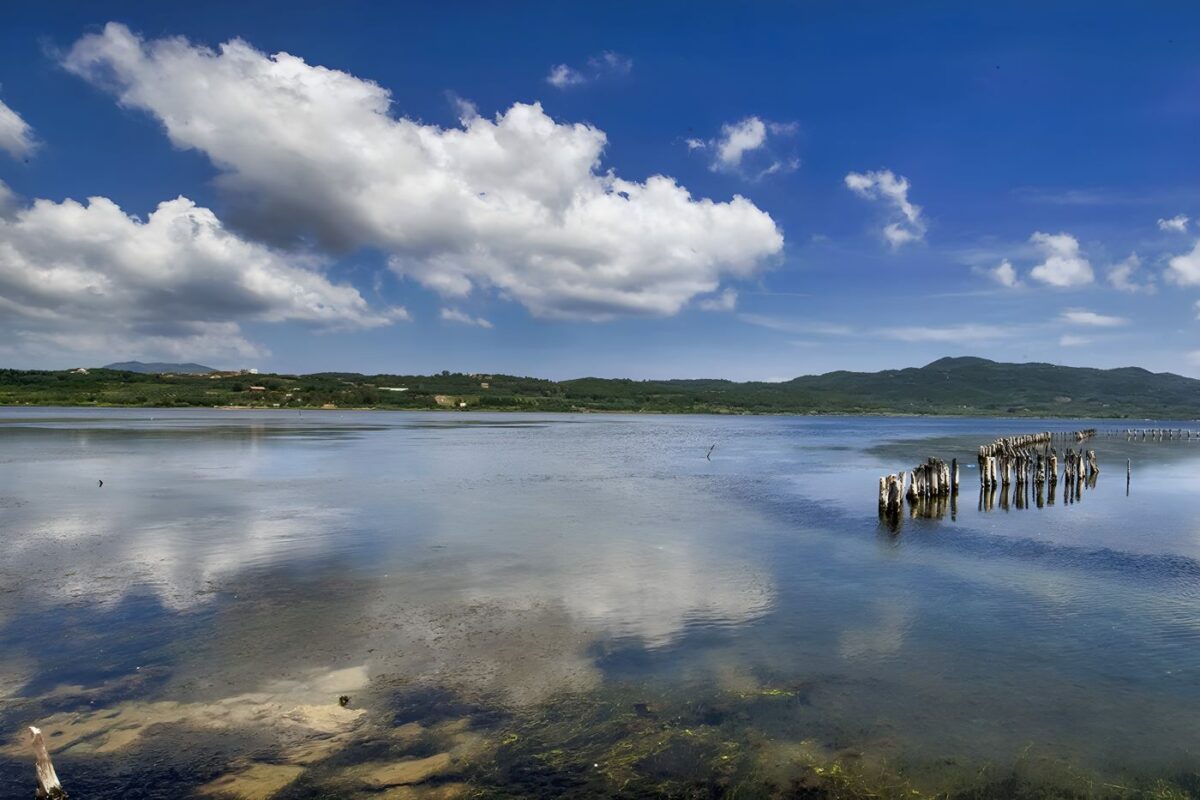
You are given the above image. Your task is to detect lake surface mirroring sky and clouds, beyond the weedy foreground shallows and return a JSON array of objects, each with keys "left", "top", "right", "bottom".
[{"left": 0, "top": 409, "right": 1200, "bottom": 777}]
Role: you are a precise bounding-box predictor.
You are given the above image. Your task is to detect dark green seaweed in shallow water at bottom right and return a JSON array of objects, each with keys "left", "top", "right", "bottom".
[{"left": 468, "top": 687, "right": 1200, "bottom": 800}]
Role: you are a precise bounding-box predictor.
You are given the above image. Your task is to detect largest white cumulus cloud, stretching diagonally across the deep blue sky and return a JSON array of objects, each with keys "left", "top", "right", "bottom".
[{"left": 64, "top": 23, "right": 784, "bottom": 319}]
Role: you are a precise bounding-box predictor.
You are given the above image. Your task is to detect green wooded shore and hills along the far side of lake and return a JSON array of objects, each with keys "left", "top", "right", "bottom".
[{"left": 0, "top": 357, "right": 1200, "bottom": 419}]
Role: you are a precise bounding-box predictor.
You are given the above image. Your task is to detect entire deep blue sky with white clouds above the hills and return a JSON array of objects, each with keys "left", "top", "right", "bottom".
[{"left": 0, "top": 2, "right": 1200, "bottom": 379}]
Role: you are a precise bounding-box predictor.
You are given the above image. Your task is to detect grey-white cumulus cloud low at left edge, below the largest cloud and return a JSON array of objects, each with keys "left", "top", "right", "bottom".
[{"left": 0, "top": 197, "right": 406, "bottom": 355}]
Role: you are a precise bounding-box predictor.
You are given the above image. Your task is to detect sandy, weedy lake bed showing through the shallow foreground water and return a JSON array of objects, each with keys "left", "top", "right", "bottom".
[{"left": 9, "top": 669, "right": 1200, "bottom": 800}]
